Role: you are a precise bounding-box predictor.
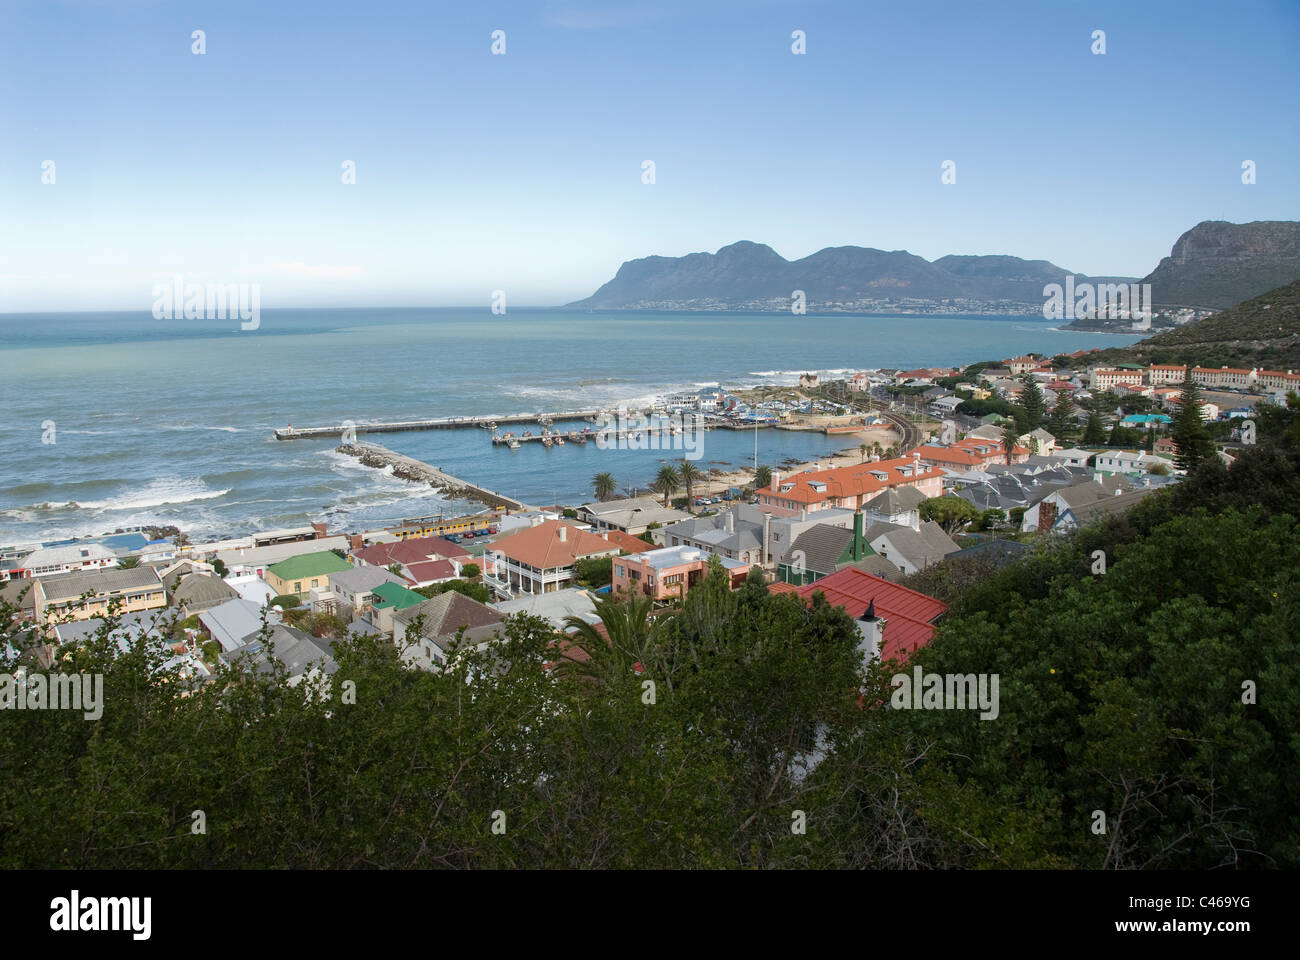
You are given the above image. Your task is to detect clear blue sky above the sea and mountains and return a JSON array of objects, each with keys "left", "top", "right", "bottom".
[{"left": 0, "top": 0, "right": 1300, "bottom": 312}]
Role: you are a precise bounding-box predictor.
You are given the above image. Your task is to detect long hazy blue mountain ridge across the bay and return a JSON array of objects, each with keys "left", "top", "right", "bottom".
[{"left": 568, "top": 241, "right": 1134, "bottom": 312}]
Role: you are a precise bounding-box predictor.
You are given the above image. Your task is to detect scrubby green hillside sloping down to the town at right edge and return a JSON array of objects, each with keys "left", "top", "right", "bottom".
[{"left": 1080, "top": 280, "right": 1300, "bottom": 371}]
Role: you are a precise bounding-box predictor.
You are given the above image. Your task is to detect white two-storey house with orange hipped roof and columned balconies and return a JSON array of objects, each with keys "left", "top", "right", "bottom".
[{"left": 484, "top": 520, "right": 619, "bottom": 597}]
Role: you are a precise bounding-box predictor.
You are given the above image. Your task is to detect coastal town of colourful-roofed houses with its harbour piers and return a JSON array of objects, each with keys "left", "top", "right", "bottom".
[{"left": 0, "top": 351, "right": 1284, "bottom": 683}]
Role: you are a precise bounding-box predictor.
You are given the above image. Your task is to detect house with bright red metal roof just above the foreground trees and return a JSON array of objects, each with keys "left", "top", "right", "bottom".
[{"left": 767, "top": 567, "right": 948, "bottom": 663}]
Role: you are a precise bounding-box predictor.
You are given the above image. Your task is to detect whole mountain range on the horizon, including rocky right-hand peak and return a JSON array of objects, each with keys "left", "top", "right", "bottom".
[{"left": 568, "top": 221, "right": 1300, "bottom": 313}]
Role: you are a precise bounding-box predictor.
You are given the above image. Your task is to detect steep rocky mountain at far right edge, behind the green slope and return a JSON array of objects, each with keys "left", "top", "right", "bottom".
[{"left": 1143, "top": 220, "right": 1300, "bottom": 310}]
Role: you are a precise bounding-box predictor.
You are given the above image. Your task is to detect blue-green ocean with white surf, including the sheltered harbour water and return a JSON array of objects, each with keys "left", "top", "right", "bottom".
[{"left": 0, "top": 308, "right": 1138, "bottom": 544}]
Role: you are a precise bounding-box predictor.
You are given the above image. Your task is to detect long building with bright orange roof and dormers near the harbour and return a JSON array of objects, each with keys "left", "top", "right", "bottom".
[{"left": 755, "top": 457, "right": 944, "bottom": 513}]
